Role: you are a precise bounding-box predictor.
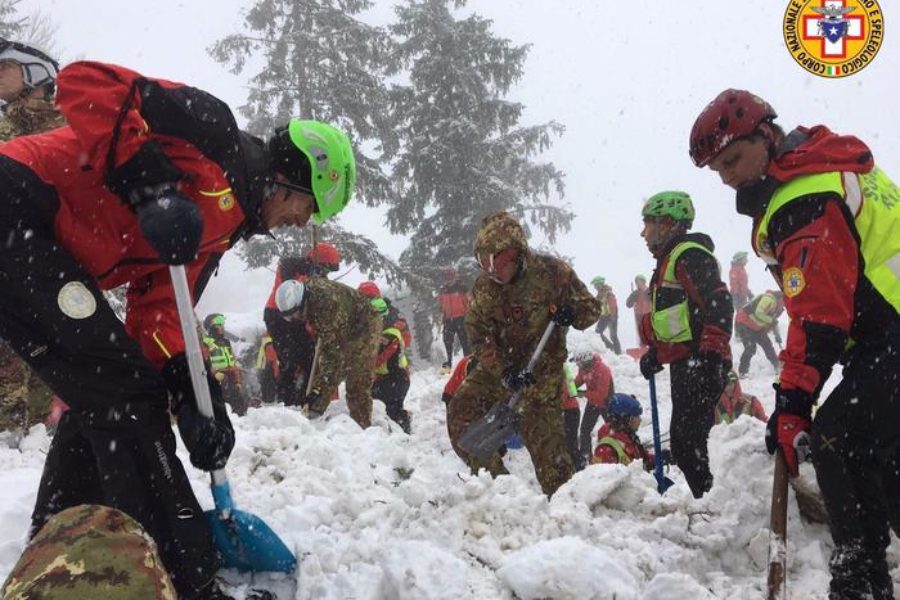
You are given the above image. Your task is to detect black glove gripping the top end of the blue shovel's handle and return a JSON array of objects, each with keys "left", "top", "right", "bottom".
[{"left": 106, "top": 141, "right": 203, "bottom": 265}]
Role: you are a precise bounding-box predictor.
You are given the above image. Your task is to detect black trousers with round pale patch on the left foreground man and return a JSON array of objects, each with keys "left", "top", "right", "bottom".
[{"left": 0, "top": 157, "right": 220, "bottom": 595}]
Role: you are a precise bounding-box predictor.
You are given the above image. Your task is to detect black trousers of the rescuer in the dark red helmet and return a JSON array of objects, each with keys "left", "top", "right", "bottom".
[{"left": 811, "top": 336, "right": 900, "bottom": 600}]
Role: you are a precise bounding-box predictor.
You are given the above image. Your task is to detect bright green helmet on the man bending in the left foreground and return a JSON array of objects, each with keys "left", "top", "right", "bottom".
[{"left": 269, "top": 119, "right": 356, "bottom": 225}]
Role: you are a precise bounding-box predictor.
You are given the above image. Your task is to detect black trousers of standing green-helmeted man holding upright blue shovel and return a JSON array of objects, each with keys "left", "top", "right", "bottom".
[{"left": 669, "top": 358, "right": 725, "bottom": 498}]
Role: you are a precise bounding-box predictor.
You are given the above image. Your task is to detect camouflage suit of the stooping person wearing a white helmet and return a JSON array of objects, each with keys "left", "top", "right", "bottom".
[{"left": 303, "top": 277, "right": 382, "bottom": 429}]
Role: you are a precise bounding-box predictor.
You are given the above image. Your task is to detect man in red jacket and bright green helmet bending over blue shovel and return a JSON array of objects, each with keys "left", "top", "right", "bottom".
[{"left": 0, "top": 62, "right": 355, "bottom": 599}]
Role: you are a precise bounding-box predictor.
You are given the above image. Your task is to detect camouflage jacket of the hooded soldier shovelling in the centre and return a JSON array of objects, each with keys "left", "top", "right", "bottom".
[{"left": 466, "top": 252, "right": 600, "bottom": 377}]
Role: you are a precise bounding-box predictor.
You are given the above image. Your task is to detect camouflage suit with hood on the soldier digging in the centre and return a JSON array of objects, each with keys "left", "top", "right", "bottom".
[{"left": 447, "top": 213, "right": 600, "bottom": 495}]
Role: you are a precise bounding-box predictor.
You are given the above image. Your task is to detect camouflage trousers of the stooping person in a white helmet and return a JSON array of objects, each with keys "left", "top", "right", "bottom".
[{"left": 310, "top": 319, "right": 381, "bottom": 429}]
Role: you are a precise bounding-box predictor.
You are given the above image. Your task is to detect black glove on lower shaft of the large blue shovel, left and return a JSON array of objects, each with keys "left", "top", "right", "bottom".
[{"left": 162, "top": 354, "right": 234, "bottom": 471}]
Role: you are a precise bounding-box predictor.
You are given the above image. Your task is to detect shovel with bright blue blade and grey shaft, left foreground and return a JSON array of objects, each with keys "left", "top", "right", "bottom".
[{"left": 169, "top": 265, "right": 297, "bottom": 573}]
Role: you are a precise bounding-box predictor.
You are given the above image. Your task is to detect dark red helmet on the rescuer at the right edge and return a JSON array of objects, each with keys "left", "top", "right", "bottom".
[{"left": 690, "top": 90, "right": 778, "bottom": 167}]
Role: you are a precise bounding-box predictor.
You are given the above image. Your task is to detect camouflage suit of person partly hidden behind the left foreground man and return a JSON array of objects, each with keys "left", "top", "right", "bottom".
[{"left": 0, "top": 92, "right": 66, "bottom": 431}]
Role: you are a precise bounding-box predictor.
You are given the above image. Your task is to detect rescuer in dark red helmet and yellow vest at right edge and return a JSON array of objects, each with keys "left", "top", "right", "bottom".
[{"left": 690, "top": 89, "right": 900, "bottom": 599}]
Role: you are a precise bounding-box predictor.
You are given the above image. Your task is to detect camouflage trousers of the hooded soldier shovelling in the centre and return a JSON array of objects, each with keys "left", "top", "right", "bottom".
[{"left": 447, "top": 365, "right": 575, "bottom": 496}]
